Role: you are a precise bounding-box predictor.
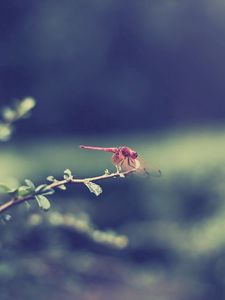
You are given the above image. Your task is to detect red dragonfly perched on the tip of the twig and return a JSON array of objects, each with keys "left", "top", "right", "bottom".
[{"left": 80, "top": 145, "right": 161, "bottom": 176}]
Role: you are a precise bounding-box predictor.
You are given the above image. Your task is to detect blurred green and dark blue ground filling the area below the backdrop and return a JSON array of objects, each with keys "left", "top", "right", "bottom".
[{"left": 0, "top": 127, "right": 225, "bottom": 300}]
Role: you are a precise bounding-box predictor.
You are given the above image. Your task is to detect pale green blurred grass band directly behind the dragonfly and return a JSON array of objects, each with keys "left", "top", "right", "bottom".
[{"left": 0, "top": 128, "right": 225, "bottom": 178}]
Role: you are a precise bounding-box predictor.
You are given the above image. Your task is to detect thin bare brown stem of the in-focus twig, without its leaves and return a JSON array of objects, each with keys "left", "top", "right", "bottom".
[{"left": 0, "top": 169, "right": 136, "bottom": 214}]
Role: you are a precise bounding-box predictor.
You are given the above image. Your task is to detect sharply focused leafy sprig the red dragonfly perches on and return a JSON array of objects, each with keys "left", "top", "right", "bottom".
[{"left": 0, "top": 169, "right": 136, "bottom": 214}]
